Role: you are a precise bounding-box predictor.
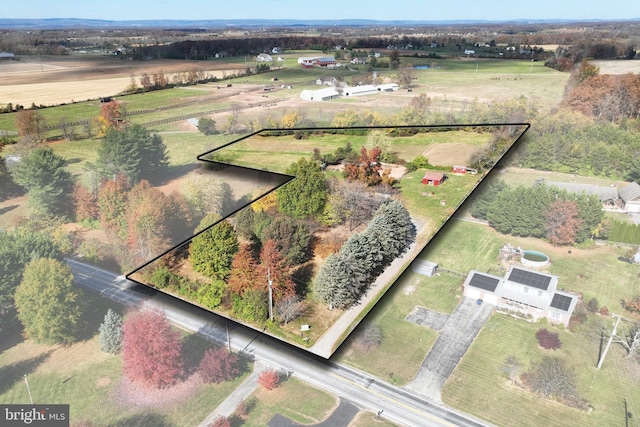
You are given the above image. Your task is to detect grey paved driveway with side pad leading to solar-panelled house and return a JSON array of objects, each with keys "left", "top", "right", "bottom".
[{"left": 407, "top": 297, "right": 494, "bottom": 402}]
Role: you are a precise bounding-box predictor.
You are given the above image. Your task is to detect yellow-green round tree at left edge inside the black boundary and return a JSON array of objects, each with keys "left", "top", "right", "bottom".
[{"left": 189, "top": 215, "right": 239, "bottom": 279}]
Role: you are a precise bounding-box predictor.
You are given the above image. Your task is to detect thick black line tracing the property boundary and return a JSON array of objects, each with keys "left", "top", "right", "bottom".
[{"left": 125, "top": 122, "right": 531, "bottom": 344}]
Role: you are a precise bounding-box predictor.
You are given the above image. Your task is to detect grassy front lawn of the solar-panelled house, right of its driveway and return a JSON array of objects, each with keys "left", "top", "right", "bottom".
[{"left": 442, "top": 314, "right": 640, "bottom": 427}]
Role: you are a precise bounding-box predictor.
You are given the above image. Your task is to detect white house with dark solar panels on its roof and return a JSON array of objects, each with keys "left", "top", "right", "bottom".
[{"left": 463, "top": 265, "right": 578, "bottom": 326}]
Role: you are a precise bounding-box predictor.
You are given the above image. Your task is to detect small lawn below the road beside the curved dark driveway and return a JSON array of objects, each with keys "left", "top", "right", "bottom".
[{"left": 234, "top": 378, "right": 338, "bottom": 427}]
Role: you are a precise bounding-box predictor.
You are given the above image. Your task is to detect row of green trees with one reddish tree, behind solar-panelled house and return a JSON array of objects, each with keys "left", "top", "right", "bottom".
[{"left": 471, "top": 181, "right": 604, "bottom": 245}]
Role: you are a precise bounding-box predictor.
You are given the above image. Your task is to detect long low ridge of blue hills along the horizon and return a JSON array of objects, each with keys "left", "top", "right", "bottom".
[{"left": 0, "top": 18, "right": 640, "bottom": 29}]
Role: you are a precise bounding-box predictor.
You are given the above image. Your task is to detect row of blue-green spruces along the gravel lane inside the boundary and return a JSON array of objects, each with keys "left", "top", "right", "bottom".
[{"left": 313, "top": 200, "right": 416, "bottom": 308}]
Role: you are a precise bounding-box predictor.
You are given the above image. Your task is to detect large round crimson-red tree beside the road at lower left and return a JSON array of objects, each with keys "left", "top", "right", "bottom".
[{"left": 122, "top": 310, "right": 183, "bottom": 388}]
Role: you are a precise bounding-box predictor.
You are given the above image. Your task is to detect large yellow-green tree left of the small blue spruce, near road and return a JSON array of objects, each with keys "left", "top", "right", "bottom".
[{"left": 15, "top": 258, "right": 83, "bottom": 345}]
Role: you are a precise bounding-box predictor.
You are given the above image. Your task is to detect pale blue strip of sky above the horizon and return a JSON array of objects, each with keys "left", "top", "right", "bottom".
[{"left": 0, "top": 0, "right": 640, "bottom": 21}]
